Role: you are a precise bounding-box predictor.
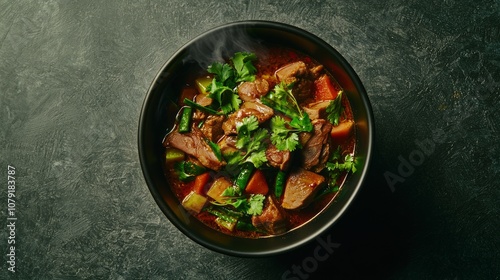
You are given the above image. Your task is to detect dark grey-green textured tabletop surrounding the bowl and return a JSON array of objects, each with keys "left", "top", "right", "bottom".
[{"left": 0, "top": 0, "right": 500, "bottom": 279}]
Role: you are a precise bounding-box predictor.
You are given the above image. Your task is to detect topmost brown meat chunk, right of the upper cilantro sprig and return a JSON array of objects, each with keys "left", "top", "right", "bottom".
[{"left": 275, "top": 61, "right": 314, "bottom": 102}]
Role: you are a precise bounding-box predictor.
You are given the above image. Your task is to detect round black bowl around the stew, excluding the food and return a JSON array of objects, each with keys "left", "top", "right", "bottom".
[{"left": 138, "top": 21, "right": 374, "bottom": 257}]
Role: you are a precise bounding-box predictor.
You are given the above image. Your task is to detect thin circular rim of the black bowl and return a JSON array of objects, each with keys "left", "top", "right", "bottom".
[{"left": 137, "top": 20, "right": 375, "bottom": 257}]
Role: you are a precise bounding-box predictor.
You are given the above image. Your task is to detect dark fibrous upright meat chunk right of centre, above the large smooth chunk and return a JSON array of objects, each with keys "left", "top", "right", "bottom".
[{"left": 301, "top": 119, "right": 332, "bottom": 172}]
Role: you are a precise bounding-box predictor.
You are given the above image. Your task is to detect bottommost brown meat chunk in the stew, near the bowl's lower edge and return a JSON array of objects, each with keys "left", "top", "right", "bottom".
[{"left": 252, "top": 196, "right": 286, "bottom": 234}]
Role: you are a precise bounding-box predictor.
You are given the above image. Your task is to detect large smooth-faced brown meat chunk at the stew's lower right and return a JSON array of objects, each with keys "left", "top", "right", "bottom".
[{"left": 281, "top": 168, "right": 325, "bottom": 210}]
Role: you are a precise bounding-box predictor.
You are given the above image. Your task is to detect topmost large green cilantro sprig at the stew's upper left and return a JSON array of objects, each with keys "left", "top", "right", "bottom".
[{"left": 207, "top": 52, "right": 257, "bottom": 115}]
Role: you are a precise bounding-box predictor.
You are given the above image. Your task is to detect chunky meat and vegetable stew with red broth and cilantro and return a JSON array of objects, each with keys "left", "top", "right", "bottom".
[{"left": 162, "top": 46, "right": 357, "bottom": 238}]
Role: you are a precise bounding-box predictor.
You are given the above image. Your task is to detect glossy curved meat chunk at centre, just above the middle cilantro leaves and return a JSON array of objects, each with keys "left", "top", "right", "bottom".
[{"left": 222, "top": 101, "right": 274, "bottom": 135}]
